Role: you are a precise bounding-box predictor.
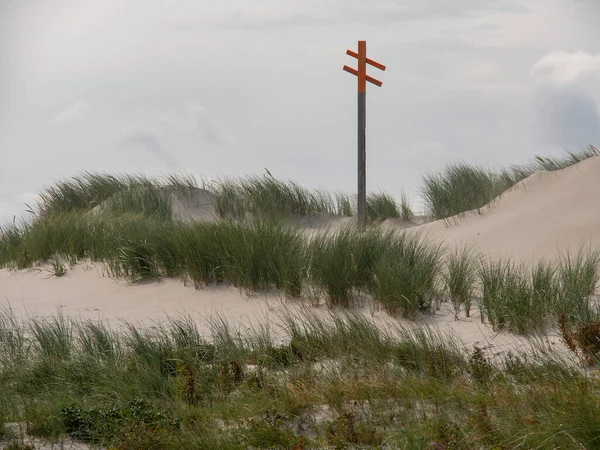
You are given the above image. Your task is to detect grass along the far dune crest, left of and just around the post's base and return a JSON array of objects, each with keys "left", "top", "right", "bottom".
[{"left": 37, "top": 172, "right": 412, "bottom": 221}]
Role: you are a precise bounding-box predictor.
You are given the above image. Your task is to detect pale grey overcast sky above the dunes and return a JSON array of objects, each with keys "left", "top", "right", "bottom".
[{"left": 0, "top": 0, "right": 600, "bottom": 222}]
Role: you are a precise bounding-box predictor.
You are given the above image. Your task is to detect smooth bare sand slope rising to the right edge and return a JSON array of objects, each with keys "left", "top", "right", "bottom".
[{"left": 416, "top": 157, "right": 600, "bottom": 262}]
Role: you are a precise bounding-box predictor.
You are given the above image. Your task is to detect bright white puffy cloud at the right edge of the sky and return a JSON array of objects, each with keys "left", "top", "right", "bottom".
[{"left": 531, "top": 51, "right": 600, "bottom": 84}]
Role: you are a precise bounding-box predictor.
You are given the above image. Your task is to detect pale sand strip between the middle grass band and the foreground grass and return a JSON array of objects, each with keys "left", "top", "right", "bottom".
[{"left": 0, "top": 264, "right": 562, "bottom": 356}]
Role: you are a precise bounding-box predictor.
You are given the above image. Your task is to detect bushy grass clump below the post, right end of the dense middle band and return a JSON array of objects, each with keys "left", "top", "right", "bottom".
[{"left": 310, "top": 229, "right": 441, "bottom": 317}]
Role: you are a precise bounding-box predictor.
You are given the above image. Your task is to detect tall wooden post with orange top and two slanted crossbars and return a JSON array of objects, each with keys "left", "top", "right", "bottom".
[{"left": 344, "top": 41, "right": 385, "bottom": 232}]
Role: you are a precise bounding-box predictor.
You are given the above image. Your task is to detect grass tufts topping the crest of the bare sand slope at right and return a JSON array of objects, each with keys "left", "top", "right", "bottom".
[{"left": 421, "top": 146, "right": 600, "bottom": 220}]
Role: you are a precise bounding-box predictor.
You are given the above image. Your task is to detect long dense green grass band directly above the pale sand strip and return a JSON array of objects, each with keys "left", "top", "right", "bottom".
[{"left": 0, "top": 213, "right": 439, "bottom": 315}]
